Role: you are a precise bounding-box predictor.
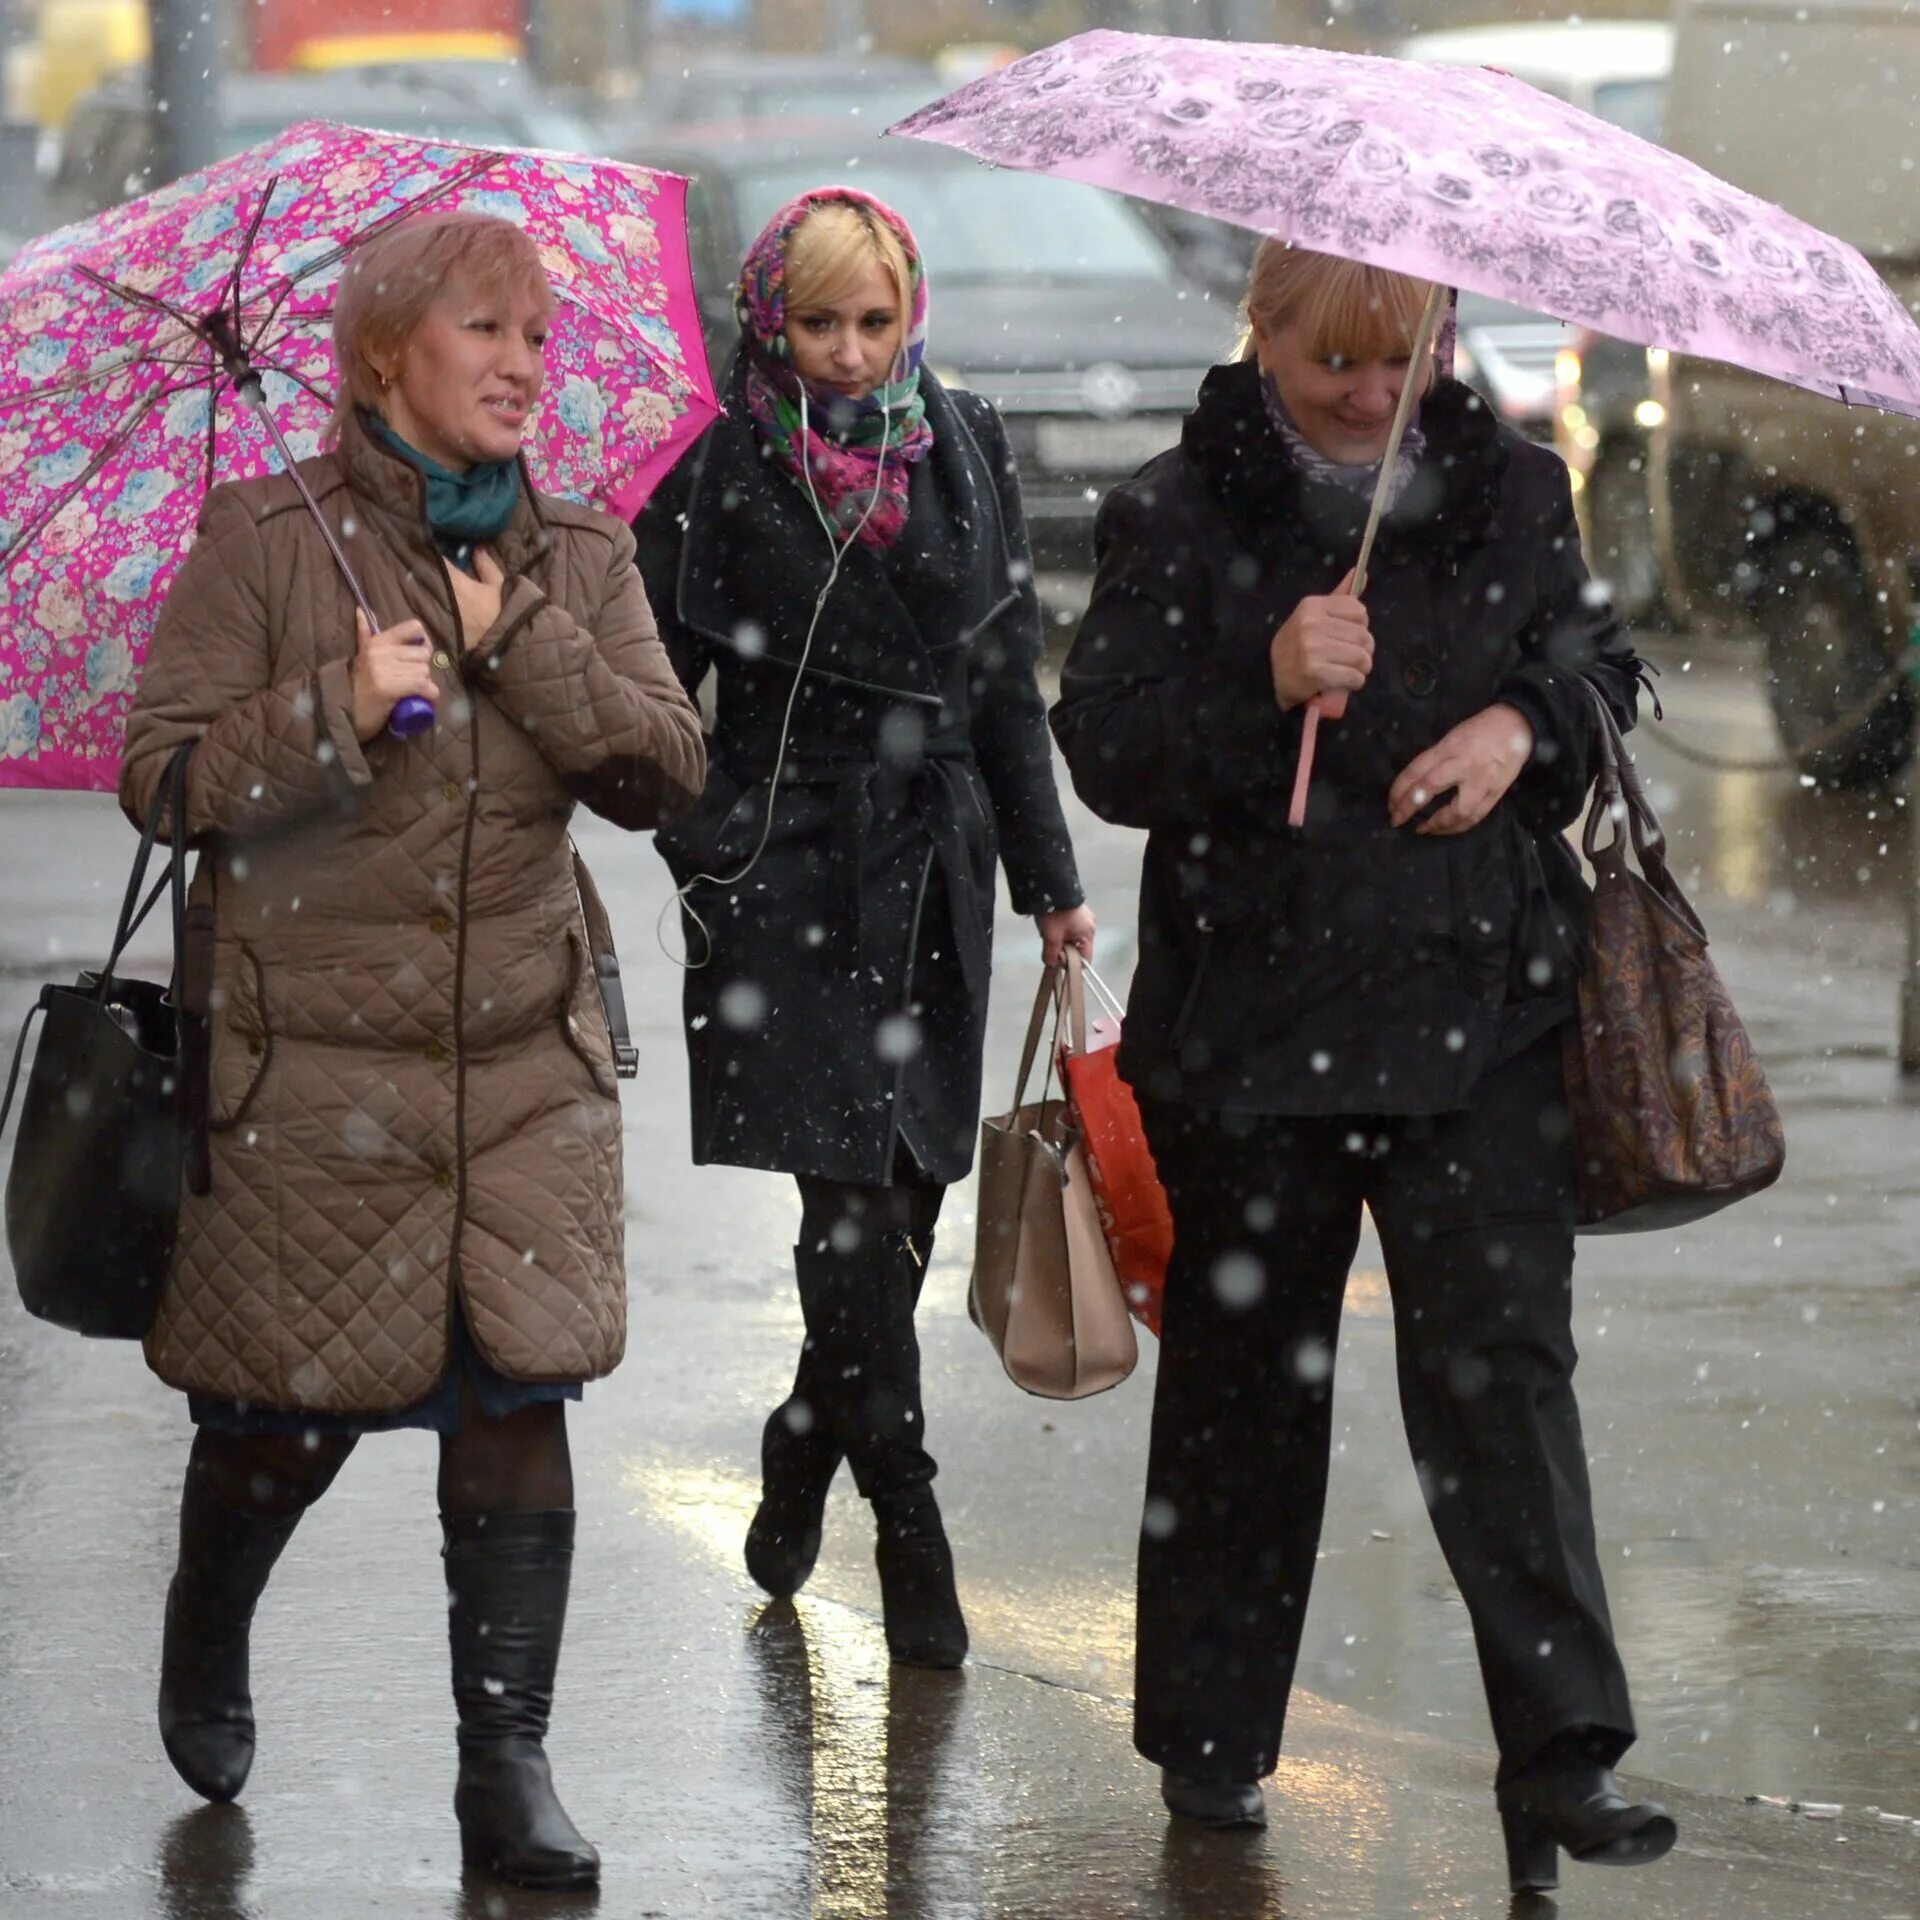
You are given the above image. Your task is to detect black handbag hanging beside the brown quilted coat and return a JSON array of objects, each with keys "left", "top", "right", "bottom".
[{"left": 0, "top": 743, "right": 207, "bottom": 1340}]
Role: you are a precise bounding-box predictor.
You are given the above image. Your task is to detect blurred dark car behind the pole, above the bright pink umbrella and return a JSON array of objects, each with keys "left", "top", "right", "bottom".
[{"left": 48, "top": 61, "right": 595, "bottom": 225}]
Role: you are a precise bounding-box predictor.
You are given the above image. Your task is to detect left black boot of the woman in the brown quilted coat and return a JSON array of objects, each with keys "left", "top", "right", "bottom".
[{"left": 159, "top": 1469, "right": 300, "bottom": 1801}]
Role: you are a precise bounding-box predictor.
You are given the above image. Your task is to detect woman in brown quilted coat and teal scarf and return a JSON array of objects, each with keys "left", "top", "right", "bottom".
[{"left": 121, "top": 213, "right": 705, "bottom": 1887}]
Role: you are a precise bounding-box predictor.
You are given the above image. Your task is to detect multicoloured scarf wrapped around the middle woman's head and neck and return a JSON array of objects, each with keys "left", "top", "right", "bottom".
[{"left": 733, "top": 186, "right": 933, "bottom": 547}]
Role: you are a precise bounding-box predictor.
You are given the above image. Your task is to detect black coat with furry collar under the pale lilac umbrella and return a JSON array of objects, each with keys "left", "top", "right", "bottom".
[{"left": 1052, "top": 363, "right": 1638, "bottom": 1116}]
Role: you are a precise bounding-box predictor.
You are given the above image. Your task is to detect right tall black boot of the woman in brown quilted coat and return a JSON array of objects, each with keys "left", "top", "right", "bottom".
[{"left": 440, "top": 1509, "right": 599, "bottom": 1889}]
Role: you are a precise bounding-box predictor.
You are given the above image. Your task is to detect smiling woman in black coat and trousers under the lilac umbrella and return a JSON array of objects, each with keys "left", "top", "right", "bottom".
[{"left": 1054, "top": 242, "right": 1674, "bottom": 1887}]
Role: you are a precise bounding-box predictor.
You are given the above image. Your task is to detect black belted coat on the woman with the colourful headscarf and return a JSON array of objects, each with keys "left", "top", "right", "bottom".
[{"left": 634, "top": 357, "right": 1081, "bottom": 1185}]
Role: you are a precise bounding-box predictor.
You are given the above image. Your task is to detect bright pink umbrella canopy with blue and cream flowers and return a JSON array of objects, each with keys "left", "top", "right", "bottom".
[{"left": 0, "top": 121, "right": 720, "bottom": 787}]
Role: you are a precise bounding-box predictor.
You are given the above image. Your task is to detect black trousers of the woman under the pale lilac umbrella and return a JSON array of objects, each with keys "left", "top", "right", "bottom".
[{"left": 1135, "top": 1033, "right": 1634, "bottom": 1782}]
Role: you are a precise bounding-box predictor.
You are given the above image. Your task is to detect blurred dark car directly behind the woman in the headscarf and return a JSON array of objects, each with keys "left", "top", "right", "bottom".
[{"left": 618, "top": 127, "right": 1233, "bottom": 568}]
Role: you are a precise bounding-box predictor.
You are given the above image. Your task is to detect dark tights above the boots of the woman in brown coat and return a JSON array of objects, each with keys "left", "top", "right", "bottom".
[{"left": 188, "top": 1394, "right": 574, "bottom": 1519}]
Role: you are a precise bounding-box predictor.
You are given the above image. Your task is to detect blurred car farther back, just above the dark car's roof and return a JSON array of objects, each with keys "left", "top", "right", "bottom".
[{"left": 611, "top": 54, "right": 936, "bottom": 138}]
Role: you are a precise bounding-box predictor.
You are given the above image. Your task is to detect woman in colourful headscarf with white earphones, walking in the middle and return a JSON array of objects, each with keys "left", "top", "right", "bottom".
[{"left": 636, "top": 186, "right": 1092, "bottom": 1667}]
